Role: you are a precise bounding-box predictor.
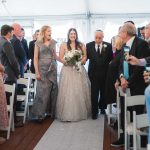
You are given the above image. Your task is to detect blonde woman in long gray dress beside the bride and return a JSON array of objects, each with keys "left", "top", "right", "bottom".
[{"left": 31, "top": 26, "right": 58, "bottom": 121}]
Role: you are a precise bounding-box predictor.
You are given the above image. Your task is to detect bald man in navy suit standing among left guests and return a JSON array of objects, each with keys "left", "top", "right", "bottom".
[{"left": 11, "top": 23, "right": 27, "bottom": 77}]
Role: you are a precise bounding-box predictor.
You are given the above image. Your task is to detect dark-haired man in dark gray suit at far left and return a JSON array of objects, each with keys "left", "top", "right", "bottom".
[{"left": 0, "top": 25, "right": 23, "bottom": 127}]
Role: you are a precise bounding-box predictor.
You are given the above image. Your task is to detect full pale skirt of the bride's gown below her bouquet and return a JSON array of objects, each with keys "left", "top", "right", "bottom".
[{"left": 56, "top": 60, "right": 91, "bottom": 121}]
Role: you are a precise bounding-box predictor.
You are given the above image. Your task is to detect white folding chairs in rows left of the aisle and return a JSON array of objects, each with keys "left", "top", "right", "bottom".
[{"left": 0, "top": 73, "right": 37, "bottom": 139}]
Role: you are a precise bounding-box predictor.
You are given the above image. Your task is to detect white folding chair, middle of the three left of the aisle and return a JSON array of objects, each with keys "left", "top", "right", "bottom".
[{"left": 16, "top": 78, "right": 30, "bottom": 123}]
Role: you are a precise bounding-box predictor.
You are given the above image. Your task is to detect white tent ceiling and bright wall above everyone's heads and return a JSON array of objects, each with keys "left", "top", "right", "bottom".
[{"left": 0, "top": 0, "right": 150, "bottom": 42}]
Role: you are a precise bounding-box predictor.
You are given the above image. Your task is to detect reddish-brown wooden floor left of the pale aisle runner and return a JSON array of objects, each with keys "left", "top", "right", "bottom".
[{"left": 0, "top": 118, "right": 53, "bottom": 150}]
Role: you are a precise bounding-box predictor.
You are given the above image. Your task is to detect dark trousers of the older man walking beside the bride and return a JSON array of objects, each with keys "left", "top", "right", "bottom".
[{"left": 91, "top": 78, "right": 107, "bottom": 116}]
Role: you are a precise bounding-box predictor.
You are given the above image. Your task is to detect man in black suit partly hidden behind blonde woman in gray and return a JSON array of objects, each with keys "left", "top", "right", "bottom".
[{"left": 29, "top": 30, "right": 39, "bottom": 73}]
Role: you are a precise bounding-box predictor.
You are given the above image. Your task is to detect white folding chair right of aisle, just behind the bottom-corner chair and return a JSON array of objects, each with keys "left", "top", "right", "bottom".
[{"left": 124, "top": 94, "right": 145, "bottom": 150}]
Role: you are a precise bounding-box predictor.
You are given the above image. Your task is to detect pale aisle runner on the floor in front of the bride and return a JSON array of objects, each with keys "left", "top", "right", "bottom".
[{"left": 34, "top": 116, "right": 104, "bottom": 150}]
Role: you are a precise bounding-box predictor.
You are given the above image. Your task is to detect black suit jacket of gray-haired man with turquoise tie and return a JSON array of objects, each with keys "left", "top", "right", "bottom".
[{"left": 120, "top": 37, "right": 150, "bottom": 95}]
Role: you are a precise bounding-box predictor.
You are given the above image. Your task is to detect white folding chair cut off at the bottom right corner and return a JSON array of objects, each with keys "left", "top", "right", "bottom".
[{"left": 133, "top": 111, "right": 149, "bottom": 150}]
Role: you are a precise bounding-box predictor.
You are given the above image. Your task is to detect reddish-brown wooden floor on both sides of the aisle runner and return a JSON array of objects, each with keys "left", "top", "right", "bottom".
[{"left": 0, "top": 118, "right": 124, "bottom": 150}]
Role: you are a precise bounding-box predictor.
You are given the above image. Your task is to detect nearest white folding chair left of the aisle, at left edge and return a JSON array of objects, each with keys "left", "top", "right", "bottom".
[{"left": 1, "top": 84, "right": 15, "bottom": 140}]
